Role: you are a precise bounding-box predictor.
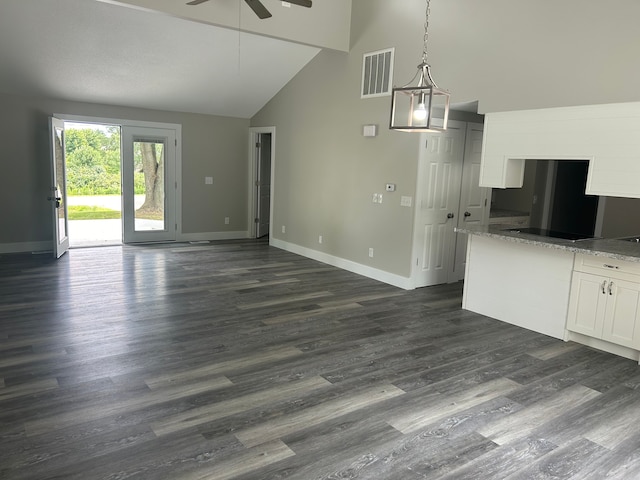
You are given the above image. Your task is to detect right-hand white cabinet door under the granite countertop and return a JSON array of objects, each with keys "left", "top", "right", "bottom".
[{"left": 602, "top": 278, "right": 640, "bottom": 349}]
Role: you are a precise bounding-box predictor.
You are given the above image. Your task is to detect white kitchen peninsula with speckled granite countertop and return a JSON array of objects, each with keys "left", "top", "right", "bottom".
[{"left": 456, "top": 225, "right": 640, "bottom": 360}]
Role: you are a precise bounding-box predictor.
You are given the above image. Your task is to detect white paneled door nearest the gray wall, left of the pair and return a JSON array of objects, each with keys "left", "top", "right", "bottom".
[{"left": 412, "top": 122, "right": 465, "bottom": 287}]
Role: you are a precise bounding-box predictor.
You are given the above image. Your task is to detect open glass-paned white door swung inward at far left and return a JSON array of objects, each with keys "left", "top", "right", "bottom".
[{"left": 49, "top": 117, "right": 69, "bottom": 258}]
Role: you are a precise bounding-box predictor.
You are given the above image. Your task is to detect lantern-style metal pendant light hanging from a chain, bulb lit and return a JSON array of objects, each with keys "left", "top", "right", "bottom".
[{"left": 389, "top": 0, "right": 450, "bottom": 132}]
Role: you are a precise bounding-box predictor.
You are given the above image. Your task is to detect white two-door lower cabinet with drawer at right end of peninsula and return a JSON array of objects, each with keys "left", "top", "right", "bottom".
[{"left": 567, "top": 259, "right": 640, "bottom": 350}]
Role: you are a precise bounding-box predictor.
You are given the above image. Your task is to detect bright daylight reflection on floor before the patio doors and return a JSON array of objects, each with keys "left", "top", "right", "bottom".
[{"left": 56, "top": 246, "right": 168, "bottom": 382}]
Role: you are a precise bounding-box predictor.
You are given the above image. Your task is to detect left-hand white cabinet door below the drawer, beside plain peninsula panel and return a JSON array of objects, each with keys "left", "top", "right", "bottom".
[{"left": 567, "top": 272, "right": 609, "bottom": 338}]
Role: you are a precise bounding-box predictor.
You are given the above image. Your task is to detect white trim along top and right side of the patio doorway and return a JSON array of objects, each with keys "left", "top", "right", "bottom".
[{"left": 53, "top": 113, "right": 182, "bottom": 241}]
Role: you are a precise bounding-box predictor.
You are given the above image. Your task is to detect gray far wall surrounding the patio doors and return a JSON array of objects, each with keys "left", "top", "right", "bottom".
[{"left": 0, "top": 94, "right": 249, "bottom": 247}]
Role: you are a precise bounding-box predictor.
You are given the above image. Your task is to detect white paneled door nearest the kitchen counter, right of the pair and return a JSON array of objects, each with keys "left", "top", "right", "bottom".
[{"left": 449, "top": 123, "right": 490, "bottom": 282}]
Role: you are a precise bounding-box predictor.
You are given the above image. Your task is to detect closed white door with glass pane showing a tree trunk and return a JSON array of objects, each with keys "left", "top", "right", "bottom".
[{"left": 122, "top": 126, "right": 177, "bottom": 243}]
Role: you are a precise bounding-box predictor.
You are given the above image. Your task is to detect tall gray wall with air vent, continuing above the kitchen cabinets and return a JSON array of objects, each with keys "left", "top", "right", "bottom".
[{"left": 251, "top": 0, "right": 640, "bottom": 276}]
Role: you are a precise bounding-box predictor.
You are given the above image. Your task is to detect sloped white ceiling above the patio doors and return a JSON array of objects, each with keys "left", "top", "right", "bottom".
[{"left": 0, "top": 0, "right": 320, "bottom": 118}]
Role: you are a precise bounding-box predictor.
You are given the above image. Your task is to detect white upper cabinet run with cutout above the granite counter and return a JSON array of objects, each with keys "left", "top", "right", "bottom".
[{"left": 480, "top": 102, "right": 640, "bottom": 198}]
